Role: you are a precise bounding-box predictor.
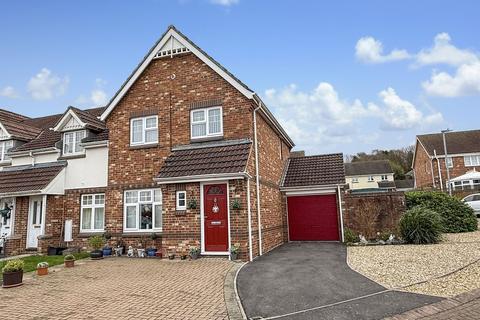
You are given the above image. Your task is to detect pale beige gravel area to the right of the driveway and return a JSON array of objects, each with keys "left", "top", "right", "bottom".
[{"left": 347, "top": 220, "right": 480, "bottom": 297}]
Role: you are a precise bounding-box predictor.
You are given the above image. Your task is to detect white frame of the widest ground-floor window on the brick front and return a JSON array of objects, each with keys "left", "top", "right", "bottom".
[{"left": 123, "top": 188, "right": 163, "bottom": 233}]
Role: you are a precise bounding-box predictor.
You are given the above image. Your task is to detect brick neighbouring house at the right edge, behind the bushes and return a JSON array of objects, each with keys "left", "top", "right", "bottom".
[{"left": 412, "top": 130, "right": 480, "bottom": 190}]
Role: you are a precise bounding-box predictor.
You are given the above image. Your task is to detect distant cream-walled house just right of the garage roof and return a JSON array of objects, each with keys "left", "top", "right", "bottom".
[{"left": 345, "top": 160, "right": 395, "bottom": 191}]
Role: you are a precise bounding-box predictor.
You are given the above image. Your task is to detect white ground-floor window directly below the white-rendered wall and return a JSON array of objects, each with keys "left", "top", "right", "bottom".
[{"left": 80, "top": 193, "right": 105, "bottom": 232}]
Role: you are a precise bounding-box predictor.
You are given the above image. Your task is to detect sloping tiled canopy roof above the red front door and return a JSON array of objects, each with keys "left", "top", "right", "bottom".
[{"left": 157, "top": 140, "right": 252, "bottom": 180}]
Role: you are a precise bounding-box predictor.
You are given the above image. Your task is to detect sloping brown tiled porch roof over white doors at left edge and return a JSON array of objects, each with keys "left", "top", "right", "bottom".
[{"left": 0, "top": 162, "right": 66, "bottom": 194}]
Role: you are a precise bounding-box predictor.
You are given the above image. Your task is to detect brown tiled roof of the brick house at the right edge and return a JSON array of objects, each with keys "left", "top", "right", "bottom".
[{"left": 417, "top": 130, "right": 480, "bottom": 156}]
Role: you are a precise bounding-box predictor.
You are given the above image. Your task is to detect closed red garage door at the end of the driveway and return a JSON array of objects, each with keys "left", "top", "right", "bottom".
[{"left": 288, "top": 194, "right": 339, "bottom": 241}]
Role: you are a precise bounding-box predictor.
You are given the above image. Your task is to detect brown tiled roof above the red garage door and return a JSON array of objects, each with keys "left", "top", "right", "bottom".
[{"left": 282, "top": 153, "right": 345, "bottom": 188}]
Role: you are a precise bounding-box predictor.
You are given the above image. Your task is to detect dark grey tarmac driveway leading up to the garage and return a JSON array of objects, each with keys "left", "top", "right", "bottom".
[{"left": 237, "top": 242, "right": 440, "bottom": 319}]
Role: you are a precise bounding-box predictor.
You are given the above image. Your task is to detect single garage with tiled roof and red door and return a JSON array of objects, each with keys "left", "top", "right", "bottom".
[{"left": 280, "top": 153, "right": 345, "bottom": 241}]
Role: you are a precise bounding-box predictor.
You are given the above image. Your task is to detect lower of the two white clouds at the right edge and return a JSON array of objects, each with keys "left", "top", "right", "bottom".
[{"left": 422, "top": 62, "right": 480, "bottom": 98}]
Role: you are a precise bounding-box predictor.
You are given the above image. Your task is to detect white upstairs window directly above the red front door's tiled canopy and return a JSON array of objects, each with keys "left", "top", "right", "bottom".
[{"left": 190, "top": 107, "right": 223, "bottom": 139}]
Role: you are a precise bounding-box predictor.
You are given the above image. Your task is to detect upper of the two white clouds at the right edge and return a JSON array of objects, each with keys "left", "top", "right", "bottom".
[{"left": 416, "top": 32, "right": 479, "bottom": 66}]
